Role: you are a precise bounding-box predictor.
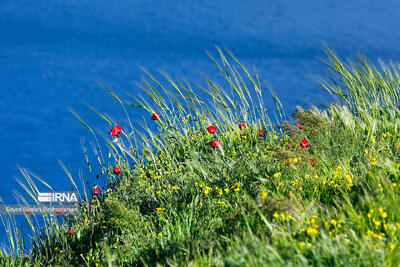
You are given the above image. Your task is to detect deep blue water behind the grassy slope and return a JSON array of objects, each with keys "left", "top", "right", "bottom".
[{"left": 0, "top": 0, "right": 400, "bottom": 249}]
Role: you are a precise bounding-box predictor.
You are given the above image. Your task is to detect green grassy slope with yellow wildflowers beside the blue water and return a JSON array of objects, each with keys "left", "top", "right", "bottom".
[{"left": 0, "top": 47, "right": 400, "bottom": 266}]
